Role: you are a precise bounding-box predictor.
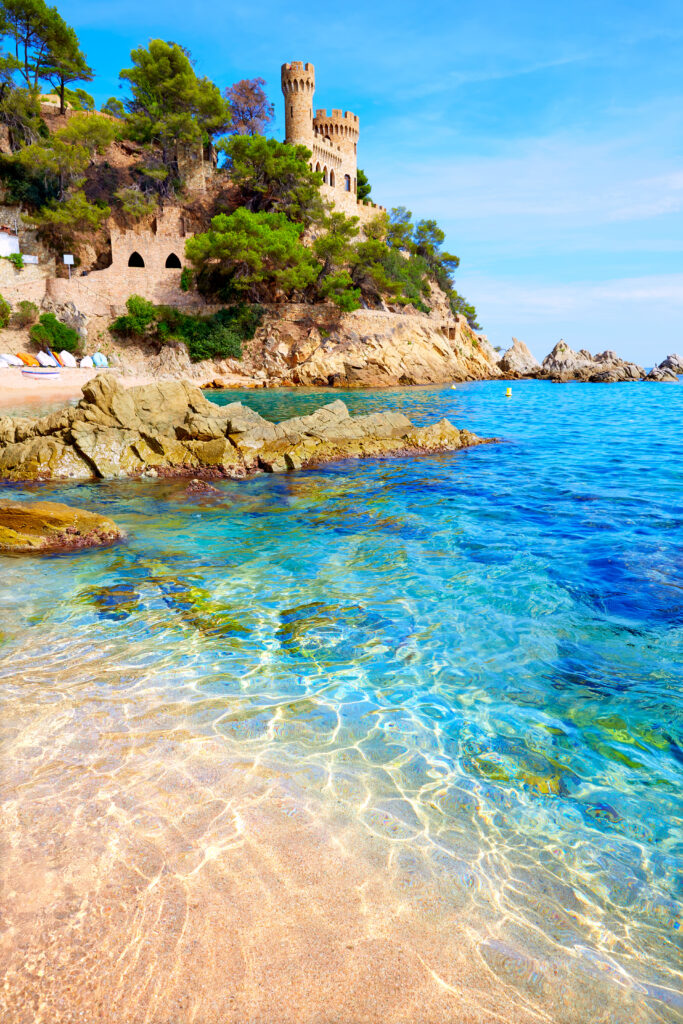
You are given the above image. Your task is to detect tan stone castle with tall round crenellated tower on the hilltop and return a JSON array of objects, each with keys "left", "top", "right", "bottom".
[{"left": 281, "top": 60, "right": 384, "bottom": 223}]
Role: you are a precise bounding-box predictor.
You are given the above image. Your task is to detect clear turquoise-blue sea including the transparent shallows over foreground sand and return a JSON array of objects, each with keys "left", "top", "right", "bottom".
[{"left": 0, "top": 382, "right": 683, "bottom": 1024}]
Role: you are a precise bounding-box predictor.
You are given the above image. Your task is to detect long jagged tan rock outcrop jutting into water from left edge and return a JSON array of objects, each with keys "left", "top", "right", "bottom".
[{"left": 0, "top": 374, "right": 493, "bottom": 480}]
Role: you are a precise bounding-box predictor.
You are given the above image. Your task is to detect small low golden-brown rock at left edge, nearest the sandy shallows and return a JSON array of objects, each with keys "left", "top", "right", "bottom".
[{"left": 0, "top": 502, "right": 124, "bottom": 554}]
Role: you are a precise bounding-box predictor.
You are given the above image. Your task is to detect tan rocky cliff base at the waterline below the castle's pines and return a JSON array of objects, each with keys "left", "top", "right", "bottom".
[{"left": 100, "top": 303, "right": 501, "bottom": 388}]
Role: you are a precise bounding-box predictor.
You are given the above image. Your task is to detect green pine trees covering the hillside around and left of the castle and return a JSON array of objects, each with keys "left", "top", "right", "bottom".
[{"left": 0, "top": 0, "right": 477, "bottom": 323}]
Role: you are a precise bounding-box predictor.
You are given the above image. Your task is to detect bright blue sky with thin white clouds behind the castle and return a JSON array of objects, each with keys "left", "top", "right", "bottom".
[{"left": 65, "top": 0, "right": 683, "bottom": 365}]
